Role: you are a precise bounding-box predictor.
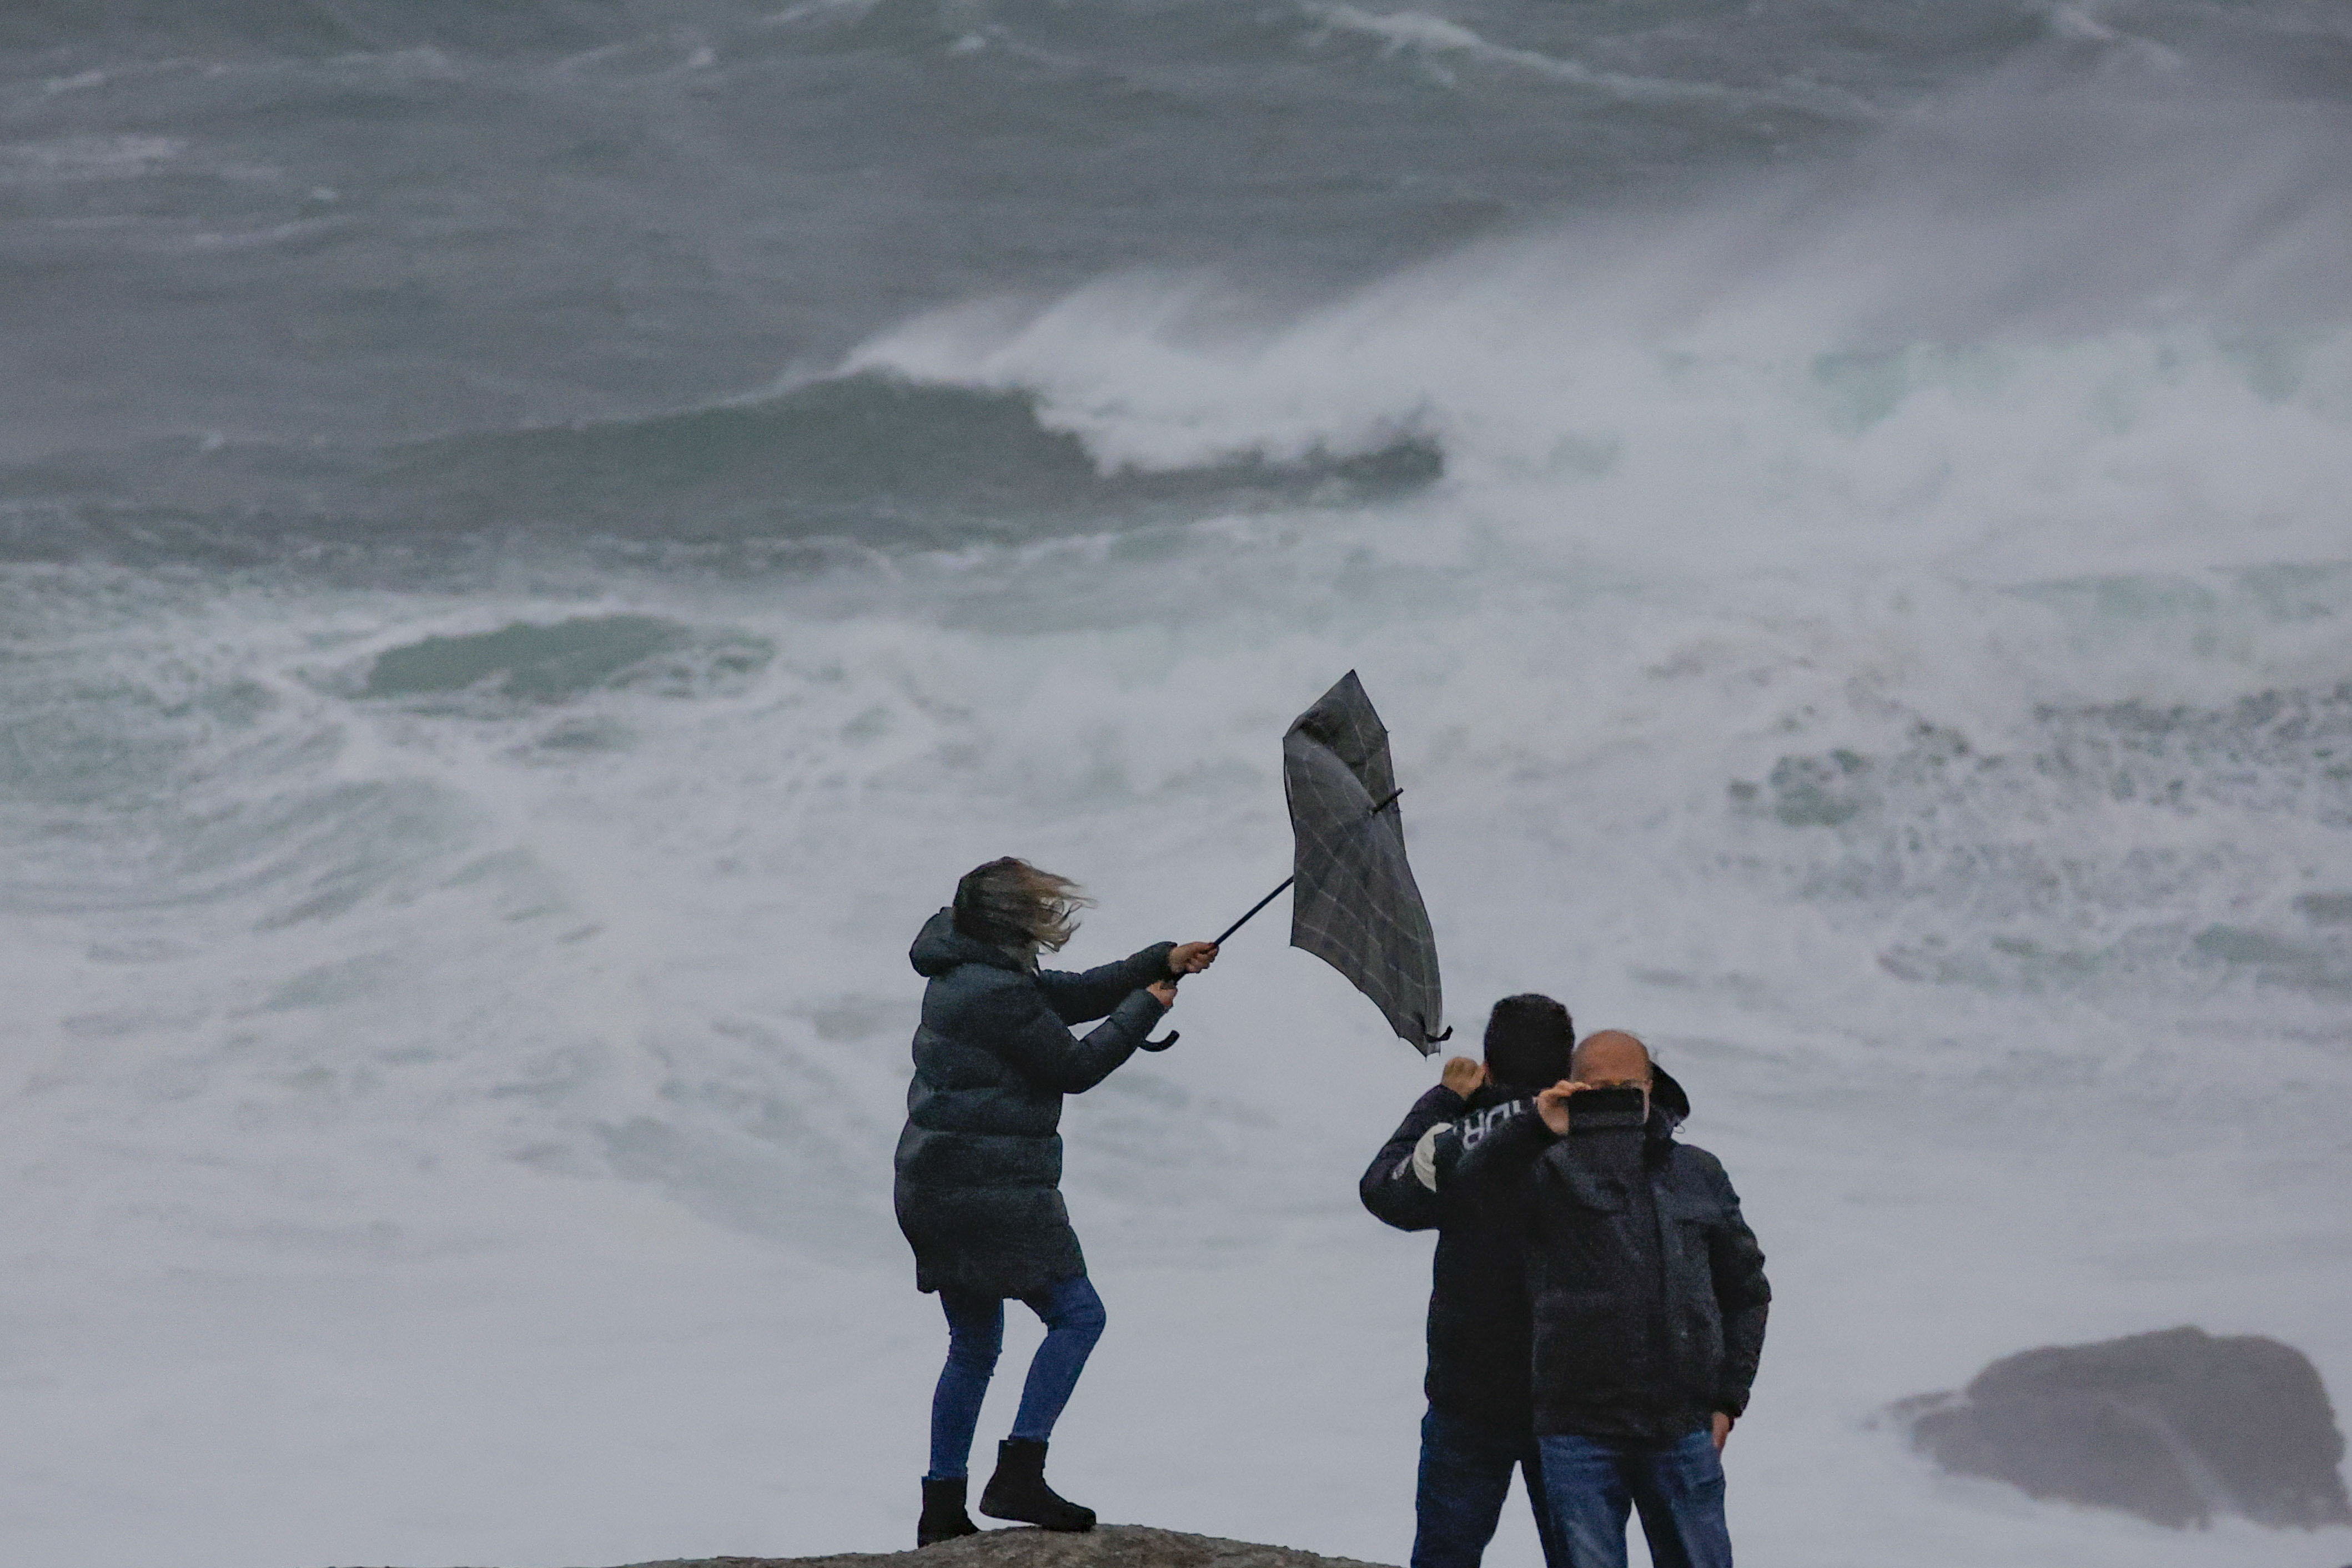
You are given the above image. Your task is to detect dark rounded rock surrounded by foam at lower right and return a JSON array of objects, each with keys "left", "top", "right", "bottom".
[{"left": 1891, "top": 1328, "right": 2352, "bottom": 1528}]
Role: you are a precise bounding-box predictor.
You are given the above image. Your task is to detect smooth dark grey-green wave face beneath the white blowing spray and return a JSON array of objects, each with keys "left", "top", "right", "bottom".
[{"left": 0, "top": 374, "right": 1444, "bottom": 564}]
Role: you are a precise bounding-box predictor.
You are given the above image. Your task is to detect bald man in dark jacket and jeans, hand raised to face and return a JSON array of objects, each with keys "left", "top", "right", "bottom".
[{"left": 1454, "top": 1029, "right": 1771, "bottom": 1568}]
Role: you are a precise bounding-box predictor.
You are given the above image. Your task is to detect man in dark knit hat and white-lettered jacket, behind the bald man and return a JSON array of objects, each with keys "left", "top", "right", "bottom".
[{"left": 1357, "top": 994, "right": 1574, "bottom": 1568}]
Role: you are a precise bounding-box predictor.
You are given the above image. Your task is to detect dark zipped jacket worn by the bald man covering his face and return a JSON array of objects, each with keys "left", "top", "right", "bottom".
[{"left": 1451, "top": 1098, "right": 1771, "bottom": 1446}]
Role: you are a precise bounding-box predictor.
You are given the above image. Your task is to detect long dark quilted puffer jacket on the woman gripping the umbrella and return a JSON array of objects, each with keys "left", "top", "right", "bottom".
[{"left": 896, "top": 910, "right": 1176, "bottom": 1298}]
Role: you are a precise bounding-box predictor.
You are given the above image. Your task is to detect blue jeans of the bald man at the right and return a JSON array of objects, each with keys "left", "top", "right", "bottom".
[{"left": 1538, "top": 1431, "right": 1731, "bottom": 1568}]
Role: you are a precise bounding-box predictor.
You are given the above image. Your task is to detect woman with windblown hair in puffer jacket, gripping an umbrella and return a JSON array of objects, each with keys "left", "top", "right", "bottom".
[{"left": 896, "top": 858, "right": 1216, "bottom": 1547}]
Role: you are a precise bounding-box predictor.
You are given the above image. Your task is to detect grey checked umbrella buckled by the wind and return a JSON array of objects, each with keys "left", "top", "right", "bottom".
[{"left": 1216, "top": 670, "right": 1454, "bottom": 1056}]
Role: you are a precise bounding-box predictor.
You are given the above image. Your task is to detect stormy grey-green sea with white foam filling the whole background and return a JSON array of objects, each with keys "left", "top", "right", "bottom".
[{"left": 0, "top": 0, "right": 2352, "bottom": 1568}]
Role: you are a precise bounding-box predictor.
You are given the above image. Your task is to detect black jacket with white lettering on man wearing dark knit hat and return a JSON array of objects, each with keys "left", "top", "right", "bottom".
[{"left": 1357, "top": 1067, "right": 1691, "bottom": 1431}]
